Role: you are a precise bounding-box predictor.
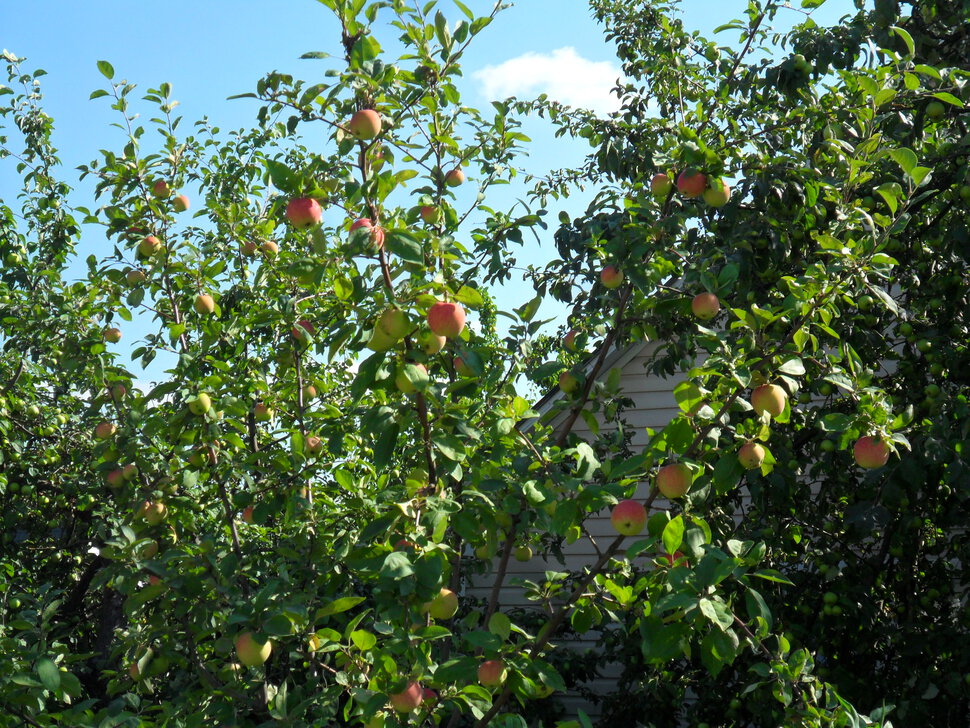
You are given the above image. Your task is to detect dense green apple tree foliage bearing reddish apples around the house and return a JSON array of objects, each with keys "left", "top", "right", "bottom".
[{"left": 0, "top": 0, "right": 970, "bottom": 726}]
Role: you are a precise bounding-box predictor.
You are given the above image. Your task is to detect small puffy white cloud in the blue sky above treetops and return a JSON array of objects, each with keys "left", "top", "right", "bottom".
[{"left": 473, "top": 47, "right": 620, "bottom": 114}]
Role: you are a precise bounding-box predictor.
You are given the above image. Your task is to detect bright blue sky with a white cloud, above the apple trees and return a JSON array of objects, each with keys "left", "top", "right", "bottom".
[{"left": 0, "top": 0, "right": 852, "bottom": 382}]
